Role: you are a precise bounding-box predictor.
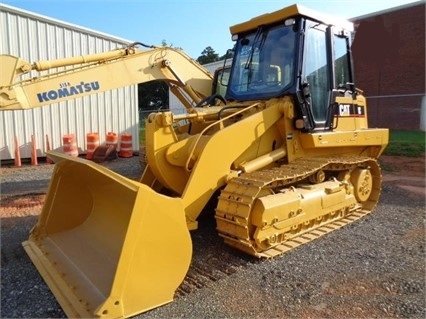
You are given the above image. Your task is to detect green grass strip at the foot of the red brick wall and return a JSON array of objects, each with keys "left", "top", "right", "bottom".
[{"left": 383, "top": 130, "right": 425, "bottom": 157}]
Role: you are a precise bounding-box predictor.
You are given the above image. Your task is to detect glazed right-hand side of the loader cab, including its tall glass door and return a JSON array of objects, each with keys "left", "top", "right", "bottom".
[{"left": 302, "top": 20, "right": 354, "bottom": 130}]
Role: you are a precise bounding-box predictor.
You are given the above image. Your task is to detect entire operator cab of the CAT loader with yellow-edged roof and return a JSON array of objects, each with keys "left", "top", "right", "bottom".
[{"left": 226, "top": 5, "right": 356, "bottom": 131}]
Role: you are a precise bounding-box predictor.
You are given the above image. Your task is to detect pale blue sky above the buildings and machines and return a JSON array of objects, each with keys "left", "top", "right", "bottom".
[{"left": 0, "top": 0, "right": 417, "bottom": 59}]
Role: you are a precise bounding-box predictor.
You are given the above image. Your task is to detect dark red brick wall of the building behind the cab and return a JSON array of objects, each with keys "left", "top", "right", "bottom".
[{"left": 352, "top": 1, "right": 426, "bottom": 130}]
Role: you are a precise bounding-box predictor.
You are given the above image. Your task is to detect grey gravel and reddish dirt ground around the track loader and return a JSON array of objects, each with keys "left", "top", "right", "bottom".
[{"left": 1, "top": 158, "right": 426, "bottom": 318}]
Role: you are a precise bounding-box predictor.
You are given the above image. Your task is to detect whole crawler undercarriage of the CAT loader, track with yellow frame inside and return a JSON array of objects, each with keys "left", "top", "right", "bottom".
[{"left": 215, "top": 156, "right": 382, "bottom": 258}]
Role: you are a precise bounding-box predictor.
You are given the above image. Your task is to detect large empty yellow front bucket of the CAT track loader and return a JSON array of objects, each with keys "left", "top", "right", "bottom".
[{"left": 23, "top": 152, "right": 192, "bottom": 318}]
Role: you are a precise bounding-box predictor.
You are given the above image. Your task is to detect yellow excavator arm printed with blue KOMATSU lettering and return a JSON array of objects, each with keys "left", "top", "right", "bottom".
[{"left": 0, "top": 43, "right": 212, "bottom": 110}]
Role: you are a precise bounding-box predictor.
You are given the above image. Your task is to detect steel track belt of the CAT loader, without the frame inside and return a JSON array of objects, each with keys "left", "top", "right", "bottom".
[{"left": 215, "top": 156, "right": 381, "bottom": 258}]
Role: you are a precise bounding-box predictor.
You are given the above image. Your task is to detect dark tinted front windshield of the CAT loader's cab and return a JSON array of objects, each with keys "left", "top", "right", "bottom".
[{"left": 227, "top": 24, "right": 296, "bottom": 101}]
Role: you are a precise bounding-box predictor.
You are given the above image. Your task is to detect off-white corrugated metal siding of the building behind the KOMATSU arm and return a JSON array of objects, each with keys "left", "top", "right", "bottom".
[{"left": 0, "top": 4, "right": 139, "bottom": 160}]
